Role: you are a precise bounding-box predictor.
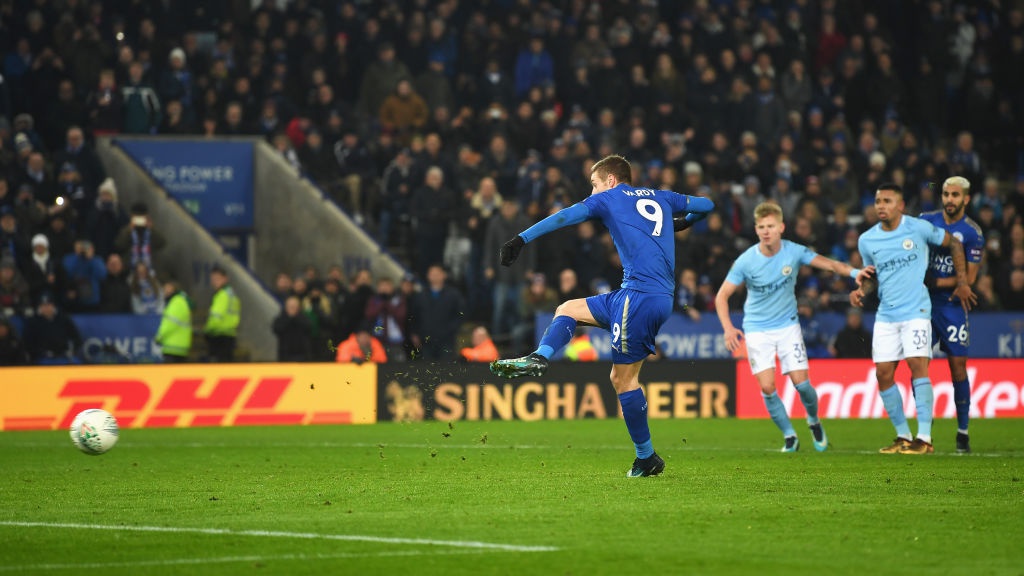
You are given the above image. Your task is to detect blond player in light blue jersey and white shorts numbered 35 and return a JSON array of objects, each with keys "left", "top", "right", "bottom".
[{"left": 715, "top": 202, "right": 870, "bottom": 452}]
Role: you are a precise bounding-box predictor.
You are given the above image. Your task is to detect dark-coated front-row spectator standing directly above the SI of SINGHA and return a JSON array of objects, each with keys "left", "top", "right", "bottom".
[{"left": 410, "top": 263, "right": 466, "bottom": 361}]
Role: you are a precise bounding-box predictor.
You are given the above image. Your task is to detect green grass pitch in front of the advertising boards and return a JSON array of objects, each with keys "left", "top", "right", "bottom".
[{"left": 0, "top": 419, "right": 1024, "bottom": 576}]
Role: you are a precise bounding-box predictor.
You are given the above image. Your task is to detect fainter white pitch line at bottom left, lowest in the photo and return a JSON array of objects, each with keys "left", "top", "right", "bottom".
[{"left": 0, "top": 549, "right": 482, "bottom": 572}]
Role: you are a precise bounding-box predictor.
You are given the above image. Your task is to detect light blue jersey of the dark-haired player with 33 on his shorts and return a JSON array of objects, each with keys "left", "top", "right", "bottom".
[{"left": 857, "top": 214, "right": 946, "bottom": 322}]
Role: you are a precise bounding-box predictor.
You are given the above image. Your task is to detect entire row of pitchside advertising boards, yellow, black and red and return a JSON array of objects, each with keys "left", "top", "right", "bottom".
[{"left": 0, "top": 360, "right": 1024, "bottom": 430}]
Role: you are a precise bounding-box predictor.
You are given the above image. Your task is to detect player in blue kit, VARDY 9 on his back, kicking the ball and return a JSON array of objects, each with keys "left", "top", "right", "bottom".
[{"left": 490, "top": 155, "right": 715, "bottom": 478}]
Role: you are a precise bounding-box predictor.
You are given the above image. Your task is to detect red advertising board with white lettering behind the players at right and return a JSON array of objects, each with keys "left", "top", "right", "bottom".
[{"left": 736, "top": 358, "right": 1024, "bottom": 418}]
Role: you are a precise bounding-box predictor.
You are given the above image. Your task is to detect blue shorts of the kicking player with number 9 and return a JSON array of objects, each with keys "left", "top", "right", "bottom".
[{"left": 587, "top": 289, "right": 672, "bottom": 364}]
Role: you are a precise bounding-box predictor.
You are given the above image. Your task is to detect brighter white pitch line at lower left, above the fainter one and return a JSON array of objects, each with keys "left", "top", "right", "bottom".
[{"left": 0, "top": 521, "right": 558, "bottom": 552}]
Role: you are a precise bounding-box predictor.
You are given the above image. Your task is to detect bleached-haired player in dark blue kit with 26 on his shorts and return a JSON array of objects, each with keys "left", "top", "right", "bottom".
[{"left": 921, "top": 176, "right": 985, "bottom": 454}]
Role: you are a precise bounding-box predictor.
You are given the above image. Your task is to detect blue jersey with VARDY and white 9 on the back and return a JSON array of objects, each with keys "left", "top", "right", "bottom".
[{"left": 582, "top": 184, "right": 696, "bottom": 295}]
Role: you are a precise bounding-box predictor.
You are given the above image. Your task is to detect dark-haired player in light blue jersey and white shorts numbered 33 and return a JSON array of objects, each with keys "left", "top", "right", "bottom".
[{"left": 850, "top": 183, "right": 977, "bottom": 454}]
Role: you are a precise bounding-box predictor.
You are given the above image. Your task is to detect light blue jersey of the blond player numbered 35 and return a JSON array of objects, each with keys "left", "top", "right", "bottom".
[{"left": 725, "top": 240, "right": 817, "bottom": 332}]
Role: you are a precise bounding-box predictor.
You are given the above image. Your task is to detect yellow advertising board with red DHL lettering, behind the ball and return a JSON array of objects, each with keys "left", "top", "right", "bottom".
[{"left": 0, "top": 364, "right": 377, "bottom": 430}]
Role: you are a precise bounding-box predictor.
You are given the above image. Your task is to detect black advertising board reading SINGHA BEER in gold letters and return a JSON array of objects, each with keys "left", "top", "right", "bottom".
[{"left": 377, "top": 360, "right": 736, "bottom": 421}]
